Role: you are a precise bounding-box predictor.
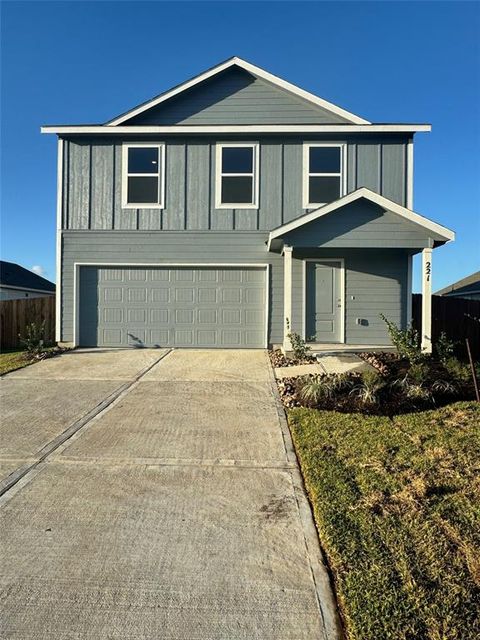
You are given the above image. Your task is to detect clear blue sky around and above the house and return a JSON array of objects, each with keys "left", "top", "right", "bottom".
[{"left": 1, "top": 1, "right": 480, "bottom": 290}]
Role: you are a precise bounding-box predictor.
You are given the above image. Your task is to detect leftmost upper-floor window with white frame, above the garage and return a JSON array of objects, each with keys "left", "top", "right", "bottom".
[{"left": 122, "top": 143, "right": 165, "bottom": 209}]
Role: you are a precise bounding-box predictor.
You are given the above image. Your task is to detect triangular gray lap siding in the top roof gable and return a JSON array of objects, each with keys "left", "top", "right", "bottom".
[{"left": 127, "top": 68, "right": 348, "bottom": 125}]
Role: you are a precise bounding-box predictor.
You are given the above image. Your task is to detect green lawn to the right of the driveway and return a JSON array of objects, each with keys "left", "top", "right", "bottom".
[{"left": 288, "top": 402, "right": 480, "bottom": 640}]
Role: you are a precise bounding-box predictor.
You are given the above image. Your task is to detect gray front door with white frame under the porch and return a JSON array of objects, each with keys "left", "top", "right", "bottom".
[{"left": 305, "top": 260, "right": 343, "bottom": 342}]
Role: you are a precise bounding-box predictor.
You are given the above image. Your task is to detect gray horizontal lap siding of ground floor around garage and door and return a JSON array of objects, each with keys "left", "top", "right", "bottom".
[{"left": 61, "top": 231, "right": 408, "bottom": 345}]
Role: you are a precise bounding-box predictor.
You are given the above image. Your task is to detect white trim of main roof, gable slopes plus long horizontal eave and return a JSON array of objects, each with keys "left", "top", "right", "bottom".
[{"left": 41, "top": 57, "right": 431, "bottom": 135}]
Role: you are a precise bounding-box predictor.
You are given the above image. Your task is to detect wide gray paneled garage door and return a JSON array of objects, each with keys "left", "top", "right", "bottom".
[{"left": 78, "top": 266, "right": 266, "bottom": 348}]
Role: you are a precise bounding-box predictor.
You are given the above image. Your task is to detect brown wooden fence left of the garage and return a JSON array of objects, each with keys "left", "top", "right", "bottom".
[{"left": 0, "top": 296, "right": 55, "bottom": 351}]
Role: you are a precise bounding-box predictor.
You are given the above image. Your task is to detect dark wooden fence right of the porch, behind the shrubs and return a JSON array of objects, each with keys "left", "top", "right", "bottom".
[{"left": 412, "top": 293, "right": 480, "bottom": 359}]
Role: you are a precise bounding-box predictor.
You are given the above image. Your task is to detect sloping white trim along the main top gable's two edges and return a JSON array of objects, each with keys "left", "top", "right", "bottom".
[{"left": 107, "top": 58, "right": 370, "bottom": 127}]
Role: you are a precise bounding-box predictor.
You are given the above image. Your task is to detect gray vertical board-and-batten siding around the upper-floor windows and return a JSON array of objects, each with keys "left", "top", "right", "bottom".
[{"left": 62, "top": 136, "right": 408, "bottom": 231}]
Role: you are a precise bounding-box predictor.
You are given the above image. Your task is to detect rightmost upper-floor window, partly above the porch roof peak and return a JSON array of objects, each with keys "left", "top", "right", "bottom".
[{"left": 303, "top": 143, "right": 345, "bottom": 209}]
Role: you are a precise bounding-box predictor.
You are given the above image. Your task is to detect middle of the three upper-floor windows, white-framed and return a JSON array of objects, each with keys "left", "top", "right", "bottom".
[{"left": 215, "top": 143, "right": 258, "bottom": 209}]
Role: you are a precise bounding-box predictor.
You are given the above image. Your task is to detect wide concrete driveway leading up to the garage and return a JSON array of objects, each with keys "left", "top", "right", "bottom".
[{"left": 0, "top": 349, "right": 339, "bottom": 640}]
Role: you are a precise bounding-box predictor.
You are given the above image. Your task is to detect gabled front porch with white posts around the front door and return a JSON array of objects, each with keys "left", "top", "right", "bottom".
[{"left": 268, "top": 188, "right": 454, "bottom": 354}]
